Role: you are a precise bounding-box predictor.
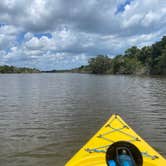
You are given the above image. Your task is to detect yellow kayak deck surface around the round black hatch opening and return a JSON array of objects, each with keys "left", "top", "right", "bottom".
[{"left": 66, "top": 114, "right": 166, "bottom": 166}]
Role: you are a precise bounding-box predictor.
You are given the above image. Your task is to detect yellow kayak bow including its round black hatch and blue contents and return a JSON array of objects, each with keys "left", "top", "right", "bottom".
[{"left": 66, "top": 114, "right": 166, "bottom": 166}]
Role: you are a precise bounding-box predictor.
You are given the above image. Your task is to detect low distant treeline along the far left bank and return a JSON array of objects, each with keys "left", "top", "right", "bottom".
[{"left": 0, "top": 65, "right": 40, "bottom": 73}]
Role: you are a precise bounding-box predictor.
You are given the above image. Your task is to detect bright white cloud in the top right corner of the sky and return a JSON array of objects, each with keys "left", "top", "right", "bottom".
[{"left": 122, "top": 0, "right": 166, "bottom": 31}]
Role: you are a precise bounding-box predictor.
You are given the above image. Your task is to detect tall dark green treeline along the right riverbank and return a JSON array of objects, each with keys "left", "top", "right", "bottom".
[{"left": 75, "top": 36, "right": 166, "bottom": 75}]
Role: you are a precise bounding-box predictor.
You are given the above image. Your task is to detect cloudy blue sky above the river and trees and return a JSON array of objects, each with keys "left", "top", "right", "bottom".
[{"left": 0, "top": 0, "right": 166, "bottom": 70}]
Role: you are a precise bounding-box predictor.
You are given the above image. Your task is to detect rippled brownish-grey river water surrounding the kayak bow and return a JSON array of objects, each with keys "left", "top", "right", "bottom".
[{"left": 0, "top": 74, "right": 166, "bottom": 166}]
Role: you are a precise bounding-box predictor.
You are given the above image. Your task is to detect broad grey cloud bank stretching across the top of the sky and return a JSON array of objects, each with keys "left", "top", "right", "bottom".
[{"left": 0, "top": 0, "right": 166, "bottom": 35}]
